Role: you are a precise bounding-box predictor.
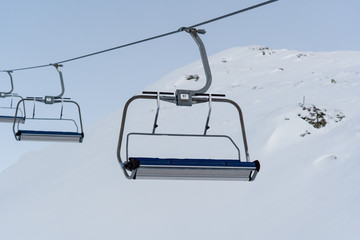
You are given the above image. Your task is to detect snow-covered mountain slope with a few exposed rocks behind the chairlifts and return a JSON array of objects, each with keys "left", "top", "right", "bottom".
[{"left": 0, "top": 46, "right": 360, "bottom": 240}]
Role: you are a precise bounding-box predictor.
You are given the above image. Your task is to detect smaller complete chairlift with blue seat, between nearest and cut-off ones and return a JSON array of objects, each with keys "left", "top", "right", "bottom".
[{"left": 13, "top": 64, "right": 84, "bottom": 143}]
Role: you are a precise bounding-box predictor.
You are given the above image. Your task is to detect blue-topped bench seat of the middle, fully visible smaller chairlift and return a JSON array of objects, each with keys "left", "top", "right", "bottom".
[{"left": 16, "top": 130, "right": 84, "bottom": 142}]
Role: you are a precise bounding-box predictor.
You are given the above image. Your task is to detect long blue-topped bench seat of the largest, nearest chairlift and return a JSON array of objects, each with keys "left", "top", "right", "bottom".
[{"left": 124, "top": 157, "right": 260, "bottom": 181}]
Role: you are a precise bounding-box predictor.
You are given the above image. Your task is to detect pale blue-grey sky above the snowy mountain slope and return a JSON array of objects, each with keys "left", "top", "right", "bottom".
[{"left": 0, "top": 0, "right": 360, "bottom": 171}]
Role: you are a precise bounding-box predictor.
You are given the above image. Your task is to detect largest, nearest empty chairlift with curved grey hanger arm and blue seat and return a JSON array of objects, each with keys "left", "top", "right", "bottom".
[{"left": 117, "top": 28, "right": 260, "bottom": 181}]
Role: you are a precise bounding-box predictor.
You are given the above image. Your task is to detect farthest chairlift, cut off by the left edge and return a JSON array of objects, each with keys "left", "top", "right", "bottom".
[{"left": 0, "top": 71, "right": 25, "bottom": 123}]
